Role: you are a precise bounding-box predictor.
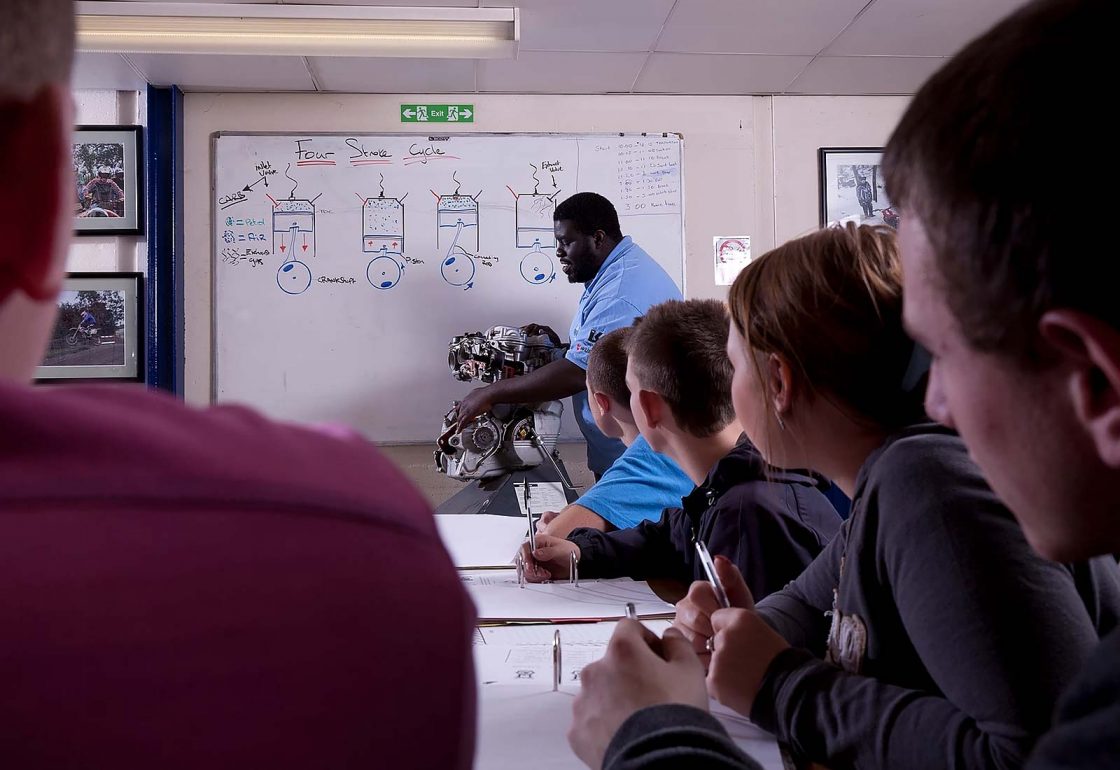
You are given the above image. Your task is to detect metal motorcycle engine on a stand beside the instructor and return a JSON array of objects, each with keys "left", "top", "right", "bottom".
[{"left": 435, "top": 326, "right": 566, "bottom": 481}]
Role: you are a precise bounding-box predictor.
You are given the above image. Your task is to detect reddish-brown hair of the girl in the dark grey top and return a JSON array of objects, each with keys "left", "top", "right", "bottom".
[{"left": 728, "top": 223, "right": 923, "bottom": 430}]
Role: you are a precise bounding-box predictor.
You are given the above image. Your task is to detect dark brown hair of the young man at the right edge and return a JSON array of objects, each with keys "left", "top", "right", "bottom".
[{"left": 883, "top": 0, "right": 1120, "bottom": 359}]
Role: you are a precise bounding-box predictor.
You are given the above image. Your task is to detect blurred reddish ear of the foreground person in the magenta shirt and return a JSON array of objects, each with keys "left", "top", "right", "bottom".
[{"left": 0, "top": 84, "right": 73, "bottom": 301}]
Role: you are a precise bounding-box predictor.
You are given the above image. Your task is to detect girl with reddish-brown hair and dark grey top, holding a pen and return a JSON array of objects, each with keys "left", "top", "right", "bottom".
[{"left": 573, "top": 225, "right": 1120, "bottom": 770}]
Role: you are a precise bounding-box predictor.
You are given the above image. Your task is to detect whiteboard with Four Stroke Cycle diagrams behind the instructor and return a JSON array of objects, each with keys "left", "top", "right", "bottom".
[{"left": 212, "top": 132, "right": 683, "bottom": 443}]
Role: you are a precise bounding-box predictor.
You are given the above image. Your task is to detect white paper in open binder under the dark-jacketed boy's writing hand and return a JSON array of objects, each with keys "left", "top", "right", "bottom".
[{"left": 459, "top": 570, "right": 675, "bottom": 621}]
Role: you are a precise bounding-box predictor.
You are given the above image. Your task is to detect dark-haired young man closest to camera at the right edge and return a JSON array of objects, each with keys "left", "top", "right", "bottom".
[{"left": 884, "top": 0, "right": 1120, "bottom": 770}]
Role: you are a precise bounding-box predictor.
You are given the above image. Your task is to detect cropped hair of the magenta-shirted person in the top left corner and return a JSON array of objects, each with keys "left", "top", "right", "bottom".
[{"left": 0, "top": 0, "right": 74, "bottom": 100}]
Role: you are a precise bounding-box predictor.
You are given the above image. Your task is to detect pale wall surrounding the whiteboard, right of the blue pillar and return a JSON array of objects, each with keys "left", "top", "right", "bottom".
[{"left": 184, "top": 93, "right": 907, "bottom": 403}]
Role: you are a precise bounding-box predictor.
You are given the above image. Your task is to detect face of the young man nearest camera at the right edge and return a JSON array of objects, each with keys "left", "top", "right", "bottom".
[{"left": 899, "top": 216, "right": 1100, "bottom": 561}]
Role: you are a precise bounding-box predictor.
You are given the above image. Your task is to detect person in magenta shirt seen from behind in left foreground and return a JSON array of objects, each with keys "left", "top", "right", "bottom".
[{"left": 0, "top": 0, "right": 476, "bottom": 770}]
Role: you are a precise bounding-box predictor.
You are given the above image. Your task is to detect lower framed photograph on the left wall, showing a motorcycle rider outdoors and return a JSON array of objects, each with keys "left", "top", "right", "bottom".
[{"left": 35, "top": 273, "right": 144, "bottom": 382}]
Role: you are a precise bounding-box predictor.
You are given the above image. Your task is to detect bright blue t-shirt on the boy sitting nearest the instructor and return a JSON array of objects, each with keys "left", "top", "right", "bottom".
[{"left": 576, "top": 436, "right": 696, "bottom": 529}]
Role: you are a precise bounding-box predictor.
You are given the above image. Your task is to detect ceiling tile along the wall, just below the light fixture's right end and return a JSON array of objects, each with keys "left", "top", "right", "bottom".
[{"left": 478, "top": 51, "right": 646, "bottom": 94}]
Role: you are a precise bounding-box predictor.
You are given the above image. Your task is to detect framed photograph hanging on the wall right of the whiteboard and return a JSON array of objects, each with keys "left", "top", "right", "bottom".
[{"left": 816, "top": 147, "right": 898, "bottom": 229}]
